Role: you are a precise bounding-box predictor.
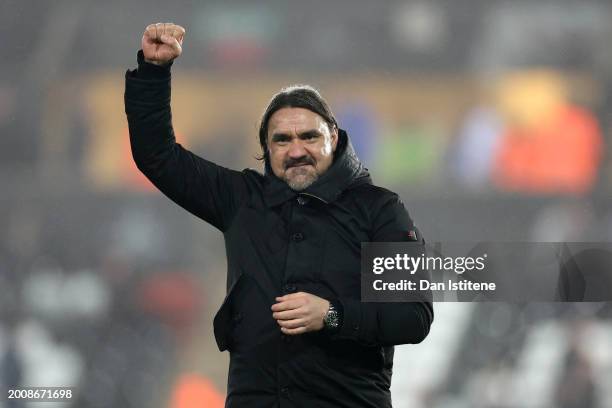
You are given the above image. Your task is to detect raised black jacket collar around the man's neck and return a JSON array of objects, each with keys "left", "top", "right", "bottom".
[{"left": 264, "top": 129, "right": 372, "bottom": 207}]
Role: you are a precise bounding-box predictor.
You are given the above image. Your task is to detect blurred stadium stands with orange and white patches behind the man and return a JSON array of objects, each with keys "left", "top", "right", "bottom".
[{"left": 0, "top": 0, "right": 612, "bottom": 408}]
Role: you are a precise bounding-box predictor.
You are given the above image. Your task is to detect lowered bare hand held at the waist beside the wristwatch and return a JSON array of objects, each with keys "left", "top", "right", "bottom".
[{"left": 272, "top": 292, "right": 329, "bottom": 335}]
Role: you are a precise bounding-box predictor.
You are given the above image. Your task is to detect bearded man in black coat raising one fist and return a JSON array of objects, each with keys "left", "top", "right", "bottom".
[{"left": 125, "top": 23, "right": 433, "bottom": 408}]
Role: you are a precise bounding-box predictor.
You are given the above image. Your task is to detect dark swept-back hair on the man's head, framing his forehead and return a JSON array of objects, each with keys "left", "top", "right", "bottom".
[{"left": 258, "top": 84, "right": 338, "bottom": 161}]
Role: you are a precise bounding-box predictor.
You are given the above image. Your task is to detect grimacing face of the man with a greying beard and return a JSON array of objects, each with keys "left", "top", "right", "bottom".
[{"left": 268, "top": 108, "right": 338, "bottom": 191}]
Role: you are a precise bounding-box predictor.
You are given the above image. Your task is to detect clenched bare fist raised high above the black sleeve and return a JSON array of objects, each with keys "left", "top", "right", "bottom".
[{"left": 142, "top": 23, "right": 185, "bottom": 65}]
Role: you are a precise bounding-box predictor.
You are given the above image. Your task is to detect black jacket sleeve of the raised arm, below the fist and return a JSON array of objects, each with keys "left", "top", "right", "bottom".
[{"left": 124, "top": 50, "right": 247, "bottom": 231}]
